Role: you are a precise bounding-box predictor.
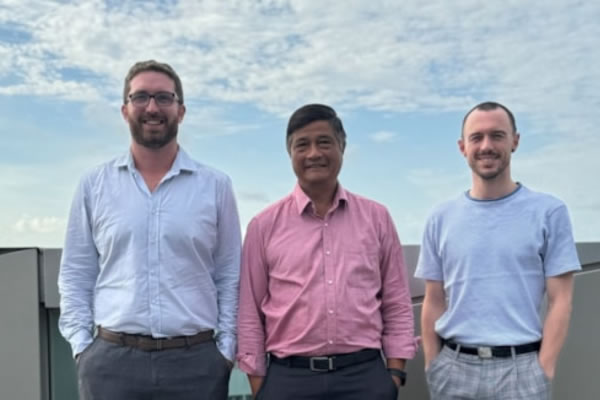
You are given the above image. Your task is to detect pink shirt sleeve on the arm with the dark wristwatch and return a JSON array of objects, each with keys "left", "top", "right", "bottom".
[{"left": 379, "top": 211, "right": 417, "bottom": 359}]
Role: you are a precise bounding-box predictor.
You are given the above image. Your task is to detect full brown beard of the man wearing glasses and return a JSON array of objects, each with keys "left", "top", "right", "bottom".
[{"left": 129, "top": 113, "right": 179, "bottom": 150}]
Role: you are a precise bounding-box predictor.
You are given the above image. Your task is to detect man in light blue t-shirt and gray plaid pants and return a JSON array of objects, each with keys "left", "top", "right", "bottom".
[{"left": 415, "top": 102, "right": 580, "bottom": 400}]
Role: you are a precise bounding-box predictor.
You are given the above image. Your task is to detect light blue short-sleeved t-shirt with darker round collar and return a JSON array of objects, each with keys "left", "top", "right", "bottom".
[{"left": 415, "top": 185, "right": 581, "bottom": 346}]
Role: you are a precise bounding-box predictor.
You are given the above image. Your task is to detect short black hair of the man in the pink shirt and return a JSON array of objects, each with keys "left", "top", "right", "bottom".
[{"left": 286, "top": 104, "right": 346, "bottom": 153}]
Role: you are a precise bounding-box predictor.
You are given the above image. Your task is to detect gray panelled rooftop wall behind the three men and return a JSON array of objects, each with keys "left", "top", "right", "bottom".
[{"left": 0, "top": 243, "right": 600, "bottom": 400}]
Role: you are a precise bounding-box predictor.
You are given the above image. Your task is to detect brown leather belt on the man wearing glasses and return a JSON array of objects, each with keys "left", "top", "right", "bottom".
[{"left": 98, "top": 326, "right": 214, "bottom": 351}]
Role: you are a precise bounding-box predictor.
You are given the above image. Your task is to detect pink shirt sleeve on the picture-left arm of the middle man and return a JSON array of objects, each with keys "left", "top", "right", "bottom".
[{"left": 237, "top": 219, "right": 268, "bottom": 376}]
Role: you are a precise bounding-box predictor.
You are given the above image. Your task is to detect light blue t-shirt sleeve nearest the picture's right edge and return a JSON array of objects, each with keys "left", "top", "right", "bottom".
[{"left": 544, "top": 204, "right": 581, "bottom": 277}]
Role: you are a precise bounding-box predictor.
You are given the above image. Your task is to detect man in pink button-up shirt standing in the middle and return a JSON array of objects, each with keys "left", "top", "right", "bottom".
[{"left": 237, "top": 104, "right": 416, "bottom": 400}]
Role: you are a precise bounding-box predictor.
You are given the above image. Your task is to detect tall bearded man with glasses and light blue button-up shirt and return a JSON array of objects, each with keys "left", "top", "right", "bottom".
[{"left": 59, "top": 60, "right": 241, "bottom": 400}]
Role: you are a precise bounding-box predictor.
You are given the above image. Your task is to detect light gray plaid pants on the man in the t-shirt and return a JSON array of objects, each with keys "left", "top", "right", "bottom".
[{"left": 426, "top": 346, "right": 551, "bottom": 400}]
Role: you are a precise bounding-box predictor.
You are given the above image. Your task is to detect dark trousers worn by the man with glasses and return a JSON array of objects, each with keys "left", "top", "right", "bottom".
[{"left": 77, "top": 338, "right": 231, "bottom": 400}]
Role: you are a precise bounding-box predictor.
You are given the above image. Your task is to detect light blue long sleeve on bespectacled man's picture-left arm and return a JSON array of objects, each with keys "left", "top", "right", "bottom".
[{"left": 58, "top": 177, "right": 99, "bottom": 356}]
